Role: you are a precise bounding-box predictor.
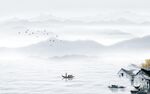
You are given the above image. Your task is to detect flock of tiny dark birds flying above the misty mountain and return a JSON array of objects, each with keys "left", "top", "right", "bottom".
[{"left": 18, "top": 29, "right": 58, "bottom": 46}]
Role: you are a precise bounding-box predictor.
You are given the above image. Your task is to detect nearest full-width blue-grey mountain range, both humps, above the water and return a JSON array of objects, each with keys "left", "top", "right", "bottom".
[{"left": 0, "top": 36, "right": 150, "bottom": 58}]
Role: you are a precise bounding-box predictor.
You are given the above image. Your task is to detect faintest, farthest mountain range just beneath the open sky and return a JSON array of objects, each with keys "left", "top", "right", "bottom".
[{"left": 0, "top": 12, "right": 150, "bottom": 27}]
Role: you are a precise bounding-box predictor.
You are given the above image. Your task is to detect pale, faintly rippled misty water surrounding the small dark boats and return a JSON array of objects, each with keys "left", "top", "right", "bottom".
[{"left": 0, "top": 53, "right": 148, "bottom": 94}]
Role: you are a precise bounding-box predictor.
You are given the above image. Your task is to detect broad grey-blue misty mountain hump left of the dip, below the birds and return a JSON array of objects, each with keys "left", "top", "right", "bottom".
[{"left": 19, "top": 39, "right": 105, "bottom": 56}]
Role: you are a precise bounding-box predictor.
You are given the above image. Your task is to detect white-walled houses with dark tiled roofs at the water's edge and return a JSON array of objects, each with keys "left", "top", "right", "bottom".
[{"left": 118, "top": 68, "right": 150, "bottom": 90}]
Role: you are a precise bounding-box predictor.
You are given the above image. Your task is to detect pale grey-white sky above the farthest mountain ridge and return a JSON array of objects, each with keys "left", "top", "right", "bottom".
[{"left": 0, "top": 0, "right": 150, "bottom": 17}]
